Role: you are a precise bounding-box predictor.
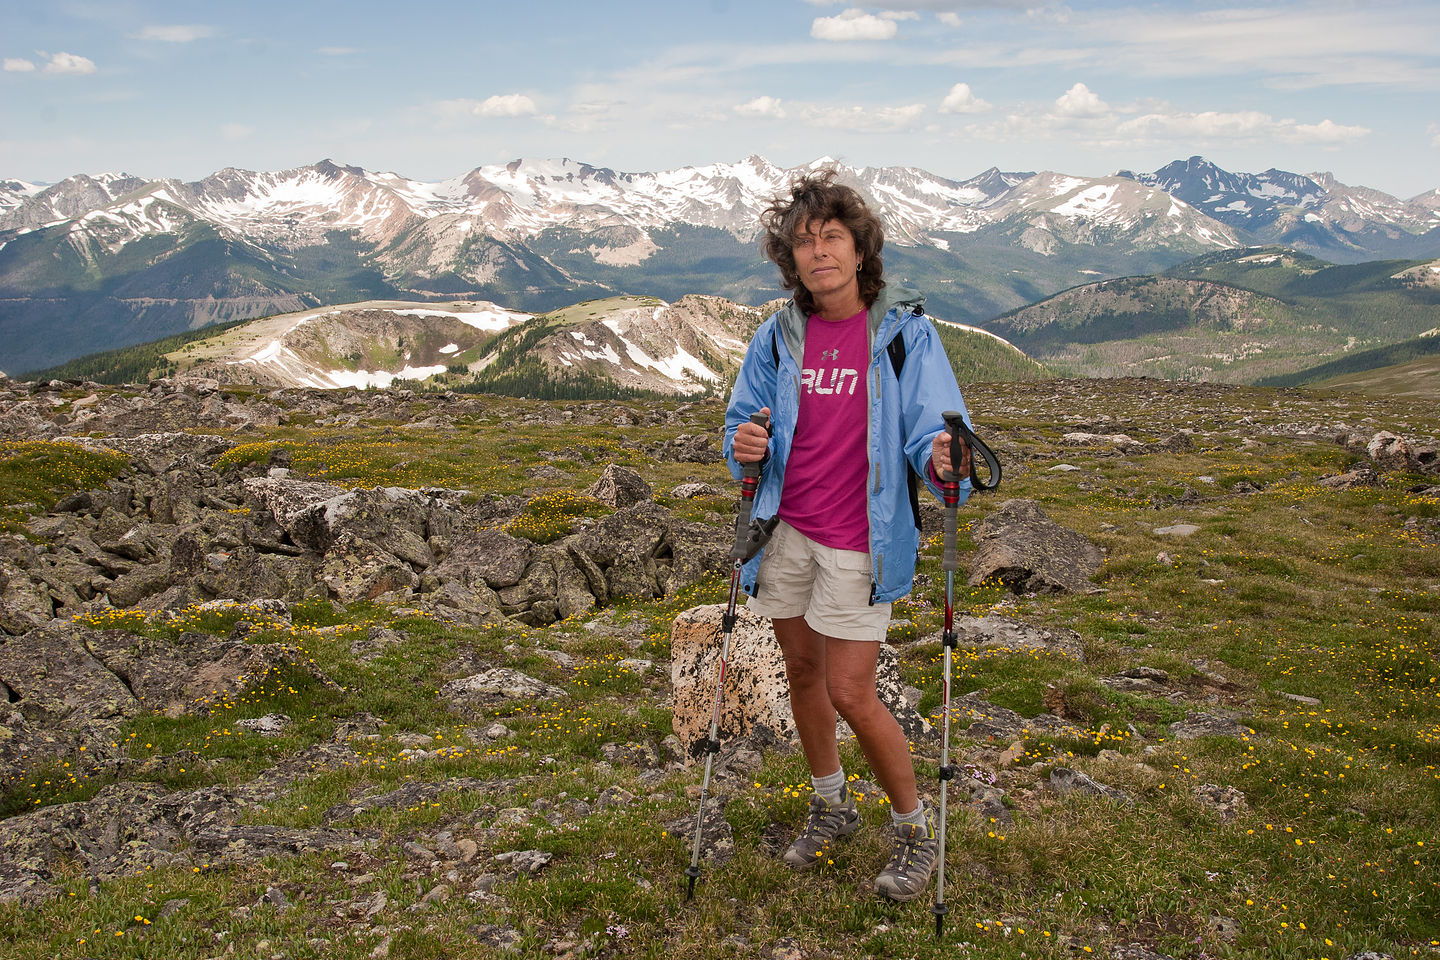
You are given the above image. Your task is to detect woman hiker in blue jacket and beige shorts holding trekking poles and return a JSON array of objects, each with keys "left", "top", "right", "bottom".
[{"left": 724, "top": 170, "right": 971, "bottom": 900}]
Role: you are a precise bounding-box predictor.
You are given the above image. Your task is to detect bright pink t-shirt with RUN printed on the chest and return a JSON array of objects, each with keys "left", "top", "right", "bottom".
[{"left": 779, "top": 311, "right": 870, "bottom": 553}]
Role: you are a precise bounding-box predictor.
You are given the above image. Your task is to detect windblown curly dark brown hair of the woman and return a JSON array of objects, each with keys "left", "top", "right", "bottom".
[{"left": 760, "top": 168, "right": 886, "bottom": 314}]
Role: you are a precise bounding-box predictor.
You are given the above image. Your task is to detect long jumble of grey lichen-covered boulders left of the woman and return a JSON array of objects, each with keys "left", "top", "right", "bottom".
[{"left": 0, "top": 433, "right": 724, "bottom": 635}]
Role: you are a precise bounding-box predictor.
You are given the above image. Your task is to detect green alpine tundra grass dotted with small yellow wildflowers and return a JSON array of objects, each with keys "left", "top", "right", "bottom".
[{"left": 0, "top": 381, "right": 1440, "bottom": 960}]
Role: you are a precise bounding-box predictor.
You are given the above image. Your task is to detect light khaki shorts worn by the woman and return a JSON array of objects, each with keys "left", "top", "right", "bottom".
[{"left": 744, "top": 520, "right": 890, "bottom": 642}]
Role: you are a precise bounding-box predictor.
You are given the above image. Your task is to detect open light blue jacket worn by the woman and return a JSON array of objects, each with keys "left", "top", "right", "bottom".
[{"left": 724, "top": 286, "right": 971, "bottom": 603}]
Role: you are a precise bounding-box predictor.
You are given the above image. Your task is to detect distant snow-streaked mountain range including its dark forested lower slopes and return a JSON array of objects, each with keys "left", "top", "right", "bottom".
[{"left": 0, "top": 157, "right": 1440, "bottom": 371}]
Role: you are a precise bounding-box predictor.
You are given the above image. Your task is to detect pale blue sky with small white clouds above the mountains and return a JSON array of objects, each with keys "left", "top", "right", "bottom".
[{"left": 0, "top": 0, "right": 1440, "bottom": 199}]
